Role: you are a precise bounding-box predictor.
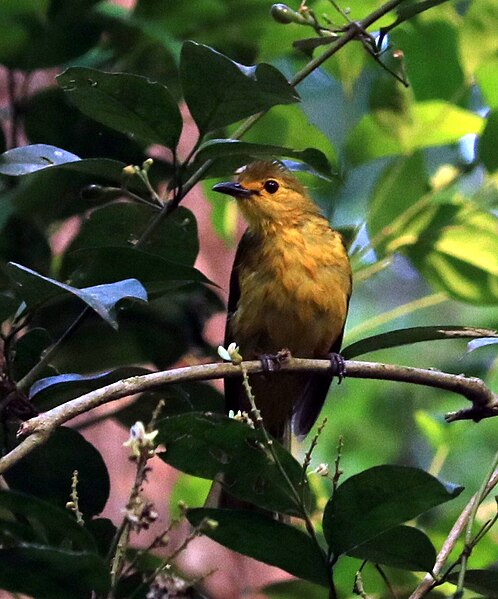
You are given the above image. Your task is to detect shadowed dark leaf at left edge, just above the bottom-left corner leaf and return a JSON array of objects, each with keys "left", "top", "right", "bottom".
[{"left": 0, "top": 490, "right": 95, "bottom": 552}]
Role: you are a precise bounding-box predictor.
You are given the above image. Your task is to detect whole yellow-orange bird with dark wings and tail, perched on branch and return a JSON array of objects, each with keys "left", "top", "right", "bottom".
[{"left": 213, "top": 160, "right": 352, "bottom": 449}]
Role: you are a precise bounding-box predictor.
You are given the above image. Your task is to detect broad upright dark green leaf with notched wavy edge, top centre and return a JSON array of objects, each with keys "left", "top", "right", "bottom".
[{"left": 180, "top": 41, "right": 299, "bottom": 136}]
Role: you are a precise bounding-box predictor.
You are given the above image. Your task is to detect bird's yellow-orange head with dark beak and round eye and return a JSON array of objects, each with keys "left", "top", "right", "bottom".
[{"left": 213, "top": 161, "right": 319, "bottom": 230}]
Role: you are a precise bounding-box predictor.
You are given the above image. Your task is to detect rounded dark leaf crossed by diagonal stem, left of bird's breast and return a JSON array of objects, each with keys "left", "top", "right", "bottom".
[{"left": 61, "top": 202, "right": 199, "bottom": 278}]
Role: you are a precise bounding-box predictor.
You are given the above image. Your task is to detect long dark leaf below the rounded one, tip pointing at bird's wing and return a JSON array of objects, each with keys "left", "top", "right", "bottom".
[{"left": 62, "top": 247, "right": 210, "bottom": 293}]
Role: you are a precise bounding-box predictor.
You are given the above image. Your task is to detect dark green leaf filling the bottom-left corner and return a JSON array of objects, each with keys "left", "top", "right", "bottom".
[{"left": 0, "top": 544, "right": 110, "bottom": 599}]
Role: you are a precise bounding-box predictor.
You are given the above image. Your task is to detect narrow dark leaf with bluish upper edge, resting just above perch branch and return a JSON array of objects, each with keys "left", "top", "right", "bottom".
[{"left": 29, "top": 366, "right": 150, "bottom": 411}]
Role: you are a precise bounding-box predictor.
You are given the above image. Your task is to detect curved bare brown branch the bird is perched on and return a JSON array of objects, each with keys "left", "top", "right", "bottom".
[{"left": 0, "top": 358, "right": 498, "bottom": 474}]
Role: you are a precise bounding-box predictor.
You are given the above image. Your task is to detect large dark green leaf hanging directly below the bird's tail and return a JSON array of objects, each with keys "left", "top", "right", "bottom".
[{"left": 157, "top": 412, "right": 312, "bottom": 517}]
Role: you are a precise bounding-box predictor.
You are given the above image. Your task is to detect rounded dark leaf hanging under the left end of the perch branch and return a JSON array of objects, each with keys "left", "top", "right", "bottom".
[{"left": 4, "top": 427, "right": 110, "bottom": 520}]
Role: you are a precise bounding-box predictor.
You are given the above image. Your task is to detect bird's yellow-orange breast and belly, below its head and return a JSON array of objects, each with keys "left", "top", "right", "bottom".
[{"left": 231, "top": 216, "right": 351, "bottom": 358}]
